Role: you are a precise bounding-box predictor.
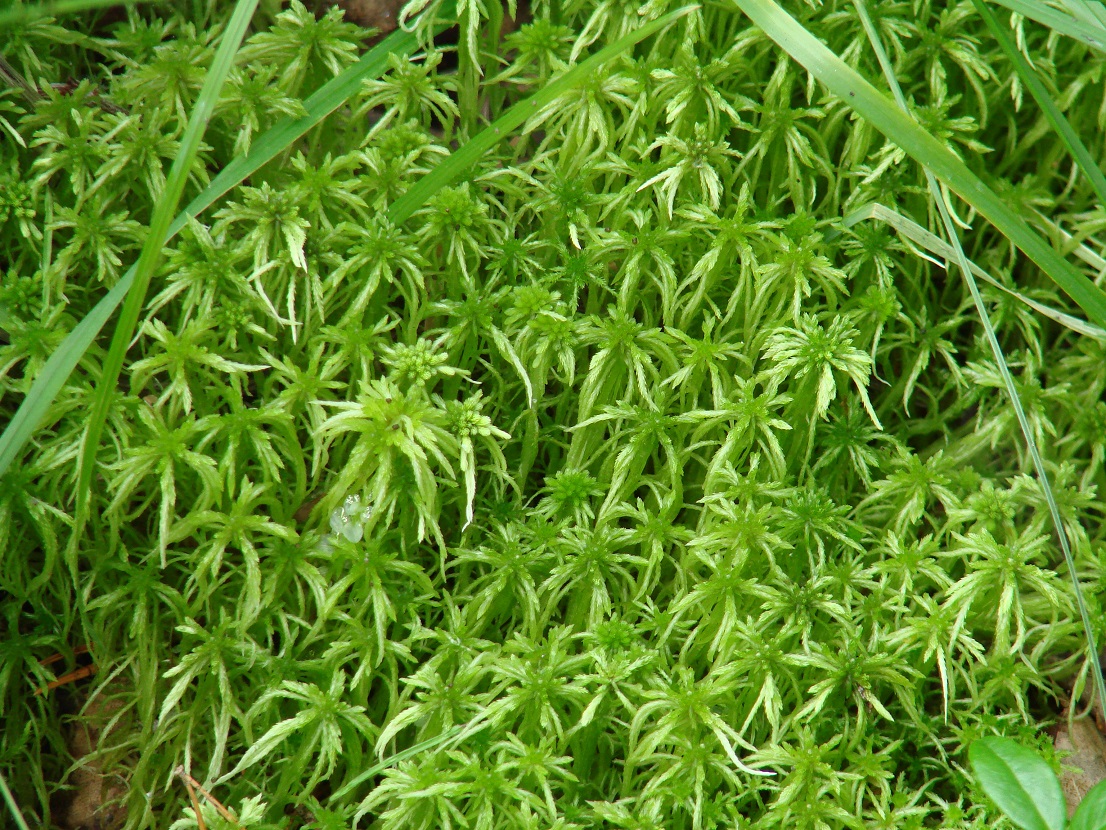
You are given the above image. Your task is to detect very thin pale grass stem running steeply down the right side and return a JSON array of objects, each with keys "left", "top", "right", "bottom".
[{"left": 853, "top": 0, "right": 1106, "bottom": 720}]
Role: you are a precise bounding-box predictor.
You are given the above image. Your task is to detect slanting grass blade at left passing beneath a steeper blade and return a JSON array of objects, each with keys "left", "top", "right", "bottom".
[{"left": 0, "top": 19, "right": 433, "bottom": 484}]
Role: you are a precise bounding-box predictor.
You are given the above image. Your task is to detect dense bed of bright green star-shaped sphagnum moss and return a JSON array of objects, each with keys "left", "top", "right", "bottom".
[{"left": 0, "top": 0, "right": 1106, "bottom": 830}]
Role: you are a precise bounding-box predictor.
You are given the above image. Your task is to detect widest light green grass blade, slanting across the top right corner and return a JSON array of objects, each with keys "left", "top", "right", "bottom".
[{"left": 733, "top": 0, "right": 1106, "bottom": 329}]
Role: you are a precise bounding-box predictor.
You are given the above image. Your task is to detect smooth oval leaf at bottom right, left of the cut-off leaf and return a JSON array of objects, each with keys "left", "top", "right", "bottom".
[{"left": 968, "top": 737, "right": 1066, "bottom": 830}]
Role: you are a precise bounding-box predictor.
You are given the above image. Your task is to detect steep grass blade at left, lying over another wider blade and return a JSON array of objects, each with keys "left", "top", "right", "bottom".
[{"left": 73, "top": 0, "right": 258, "bottom": 566}]
